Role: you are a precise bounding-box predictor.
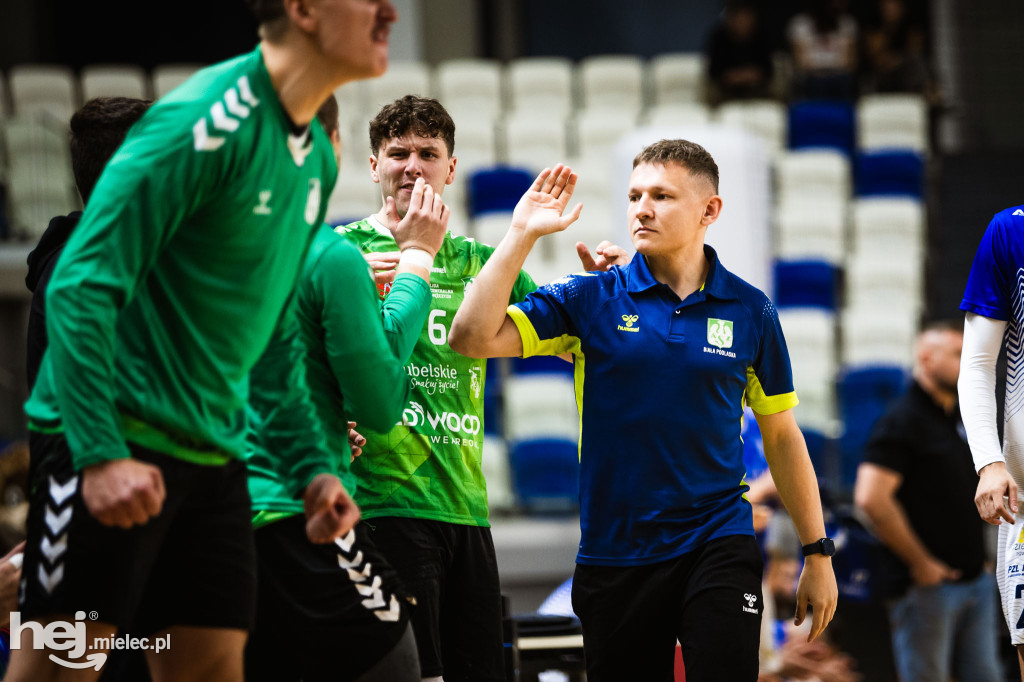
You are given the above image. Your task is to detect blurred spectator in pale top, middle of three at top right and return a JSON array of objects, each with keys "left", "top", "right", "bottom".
[{"left": 786, "top": 0, "right": 857, "bottom": 99}]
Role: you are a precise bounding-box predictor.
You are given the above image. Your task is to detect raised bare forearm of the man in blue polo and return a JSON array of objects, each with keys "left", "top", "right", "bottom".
[{"left": 449, "top": 226, "right": 536, "bottom": 357}]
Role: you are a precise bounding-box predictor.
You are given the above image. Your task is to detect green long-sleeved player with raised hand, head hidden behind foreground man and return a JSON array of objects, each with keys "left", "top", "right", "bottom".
[{"left": 246, "top": 97, "right": 449, "bottom": 682}]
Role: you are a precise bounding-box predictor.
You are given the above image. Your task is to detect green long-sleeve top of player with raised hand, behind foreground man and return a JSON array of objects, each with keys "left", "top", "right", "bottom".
[{"left": 246, "top": 225, "right": 430, "bottom": 516}]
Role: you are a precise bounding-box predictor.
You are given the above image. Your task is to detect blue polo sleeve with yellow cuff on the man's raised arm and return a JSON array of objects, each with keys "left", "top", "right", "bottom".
[{"left": 508, "top": 273, "right": 593, "bottom": 357}]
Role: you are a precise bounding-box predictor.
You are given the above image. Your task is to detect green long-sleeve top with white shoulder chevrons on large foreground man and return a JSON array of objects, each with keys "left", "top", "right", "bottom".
[{"left": 26, "top": 48, "right": 337, "bottom": 477}]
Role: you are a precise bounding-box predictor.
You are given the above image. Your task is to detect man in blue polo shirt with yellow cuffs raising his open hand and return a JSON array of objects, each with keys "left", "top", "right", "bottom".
[{"left": 449, "top": 140, "right": 837, "bottom": 682}]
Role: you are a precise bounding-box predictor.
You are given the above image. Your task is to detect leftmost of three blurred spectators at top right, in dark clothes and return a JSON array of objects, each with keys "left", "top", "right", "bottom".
[{"left": 708, "top": 0, "right": 773, "bottom": 104}]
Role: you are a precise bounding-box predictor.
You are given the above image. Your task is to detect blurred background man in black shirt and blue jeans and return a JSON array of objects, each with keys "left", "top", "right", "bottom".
[{"left": 854, "top": 322, "right": 1004, "bottom": 682}]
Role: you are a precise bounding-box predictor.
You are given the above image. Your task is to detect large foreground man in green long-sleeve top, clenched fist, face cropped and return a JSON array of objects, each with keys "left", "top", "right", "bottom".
[{"left": 14, "top": 0, "right": 395, "bottom": 682}]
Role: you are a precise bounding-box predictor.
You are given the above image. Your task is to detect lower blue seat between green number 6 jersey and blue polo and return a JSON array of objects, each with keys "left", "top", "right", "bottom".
[{"left": 509, "top": 438, "right": 580, "bottom": 512}]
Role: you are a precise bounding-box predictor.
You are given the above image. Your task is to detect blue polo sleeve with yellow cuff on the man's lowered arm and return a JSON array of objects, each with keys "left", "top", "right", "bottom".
[{"left": 745, "top": 297, "right": 799, "bottom": 415}]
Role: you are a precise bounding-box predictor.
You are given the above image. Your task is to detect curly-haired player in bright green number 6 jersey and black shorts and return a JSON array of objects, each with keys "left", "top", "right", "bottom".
[{"left": 344, "top": 95, "right": 624, "bottom": 682}]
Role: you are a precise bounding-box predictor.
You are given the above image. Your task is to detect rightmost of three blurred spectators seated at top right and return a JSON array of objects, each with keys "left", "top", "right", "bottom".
[{"left": 863, "top": 0, "right": 930, "bottom": 94}]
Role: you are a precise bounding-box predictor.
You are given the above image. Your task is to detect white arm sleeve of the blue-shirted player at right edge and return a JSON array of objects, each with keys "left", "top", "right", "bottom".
[{"left": 957, "top": 312, "right": 1007, "bottom": 471}]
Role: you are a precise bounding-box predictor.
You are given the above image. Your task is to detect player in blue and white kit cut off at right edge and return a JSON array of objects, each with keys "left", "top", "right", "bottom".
[{"left": 957, "top": 206, "right": 1024, "bottom": 680}]
